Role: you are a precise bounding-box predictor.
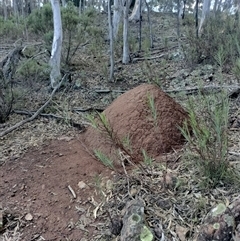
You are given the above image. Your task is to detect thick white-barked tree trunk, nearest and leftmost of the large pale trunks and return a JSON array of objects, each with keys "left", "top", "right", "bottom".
[{"left": 49, "top": 0, "right": 62, "bottom": 88}]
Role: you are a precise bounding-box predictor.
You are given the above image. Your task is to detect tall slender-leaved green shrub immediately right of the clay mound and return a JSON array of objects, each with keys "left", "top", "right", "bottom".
[{"left": 180, "top": 89, "right": 236, "bottom": 186}]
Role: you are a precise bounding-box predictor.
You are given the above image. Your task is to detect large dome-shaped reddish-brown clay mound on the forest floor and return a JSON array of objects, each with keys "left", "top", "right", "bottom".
[{"left": 85, "top": 84, "right": 187, "bottom": 165}]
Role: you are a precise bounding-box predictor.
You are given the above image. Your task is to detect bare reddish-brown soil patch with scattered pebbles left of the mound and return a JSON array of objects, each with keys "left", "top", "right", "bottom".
[{"left": 0, "top": 136, "right": 111, "bottom": 241}]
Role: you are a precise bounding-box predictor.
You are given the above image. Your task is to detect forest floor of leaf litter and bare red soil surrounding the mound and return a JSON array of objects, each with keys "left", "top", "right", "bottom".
[{"left": 0, "top": 11, "right": 240, "bottom": 241}]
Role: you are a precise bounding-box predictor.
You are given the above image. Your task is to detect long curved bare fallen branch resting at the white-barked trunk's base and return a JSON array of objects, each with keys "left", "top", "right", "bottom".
[{"left": 0, "top": 74, "right": 67, "bottom": 137}]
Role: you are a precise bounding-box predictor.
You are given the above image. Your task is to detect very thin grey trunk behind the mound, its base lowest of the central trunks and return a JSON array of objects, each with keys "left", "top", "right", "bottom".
[{"left": 108, "top": 0, "right": 114, "bottom": 81}]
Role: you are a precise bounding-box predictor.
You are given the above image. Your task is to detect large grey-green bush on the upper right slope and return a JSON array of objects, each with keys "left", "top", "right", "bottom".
[{"left": 183, "top": 13, "right": 240, "bottom": 70}]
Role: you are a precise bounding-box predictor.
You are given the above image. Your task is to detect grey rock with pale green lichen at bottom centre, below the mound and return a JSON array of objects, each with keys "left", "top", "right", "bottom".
[{"left": 120, "top": 199, "right": 154, "bottom": 241}]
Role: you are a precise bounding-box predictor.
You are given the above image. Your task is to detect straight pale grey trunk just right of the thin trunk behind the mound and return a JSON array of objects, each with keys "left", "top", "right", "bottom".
[{"left": 122, "top": 0, "right": 130, "bottom": 64}]
